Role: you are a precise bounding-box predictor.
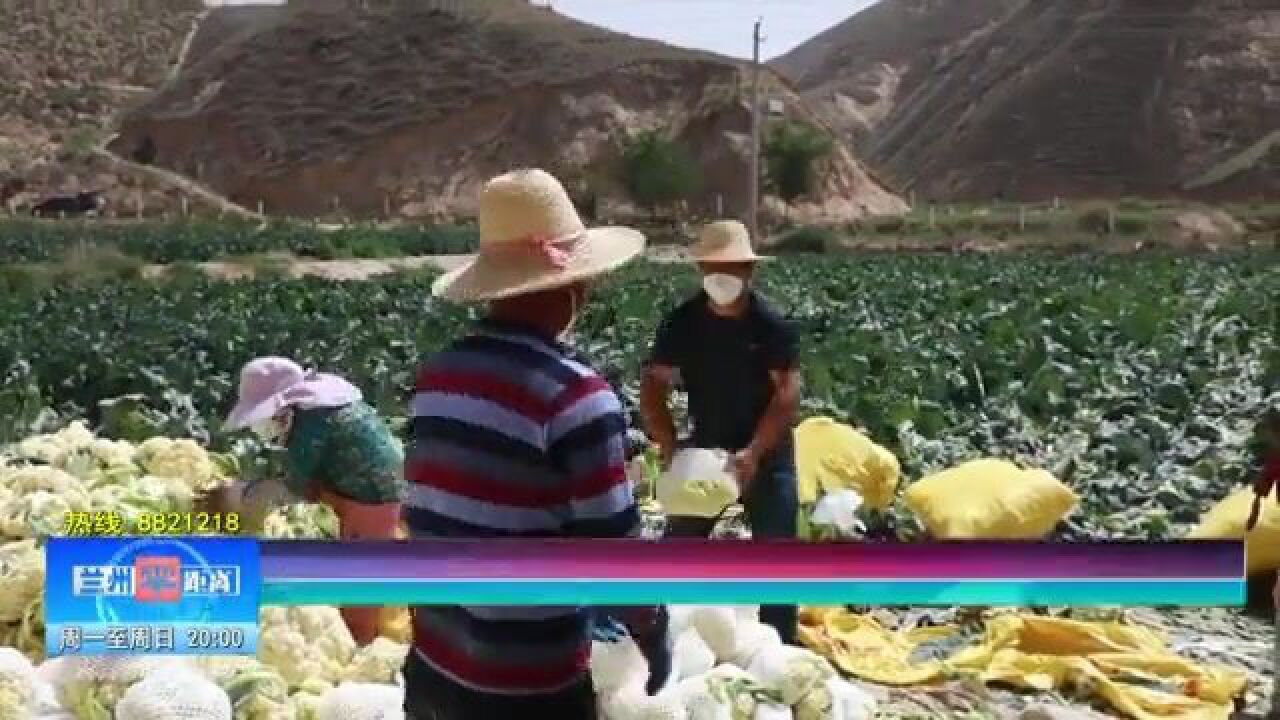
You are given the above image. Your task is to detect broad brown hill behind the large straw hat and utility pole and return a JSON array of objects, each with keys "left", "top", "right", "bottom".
[{"left": 111, "top": 0, "right": 902, "bottom": 219}]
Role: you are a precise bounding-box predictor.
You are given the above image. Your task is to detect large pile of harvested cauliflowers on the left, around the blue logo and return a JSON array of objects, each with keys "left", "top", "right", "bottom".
[{"left": 0, "top": 423, "right": 408, "bottom": 720}]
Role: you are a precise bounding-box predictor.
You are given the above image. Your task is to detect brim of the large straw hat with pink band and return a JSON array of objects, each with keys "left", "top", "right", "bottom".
[{"left": 431, "top": 227, "right": 645, "bottom": 302}]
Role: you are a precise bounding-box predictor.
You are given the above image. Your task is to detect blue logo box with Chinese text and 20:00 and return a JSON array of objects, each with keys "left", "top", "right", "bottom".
[{"left": 45, "top": 537, "right": 262, "bottom": 657}]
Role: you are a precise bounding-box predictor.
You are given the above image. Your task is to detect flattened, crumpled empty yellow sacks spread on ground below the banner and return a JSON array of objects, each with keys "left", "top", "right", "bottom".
[{"left": 800, "top": 609, "right": 1248, "bottom": 720}]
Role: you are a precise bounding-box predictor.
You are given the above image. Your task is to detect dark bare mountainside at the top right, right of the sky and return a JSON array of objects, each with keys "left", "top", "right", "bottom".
[{"left": 778, "top": 0, "right": 1280, "bottom": 200}]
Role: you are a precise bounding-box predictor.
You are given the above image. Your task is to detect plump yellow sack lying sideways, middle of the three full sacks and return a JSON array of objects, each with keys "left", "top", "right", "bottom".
[{"left": 904, "top": 457, "right": 1079, "bottom": 539}]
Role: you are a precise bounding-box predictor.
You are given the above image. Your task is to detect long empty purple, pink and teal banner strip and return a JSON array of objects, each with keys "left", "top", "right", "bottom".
[{"left": 254, "top": 539, "right": 1244, "bottom": 606}]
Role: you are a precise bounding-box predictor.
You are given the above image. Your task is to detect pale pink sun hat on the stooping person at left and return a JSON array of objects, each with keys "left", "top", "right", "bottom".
[{"left": 224, "top": 357, "right": 364, "bottom": 430}]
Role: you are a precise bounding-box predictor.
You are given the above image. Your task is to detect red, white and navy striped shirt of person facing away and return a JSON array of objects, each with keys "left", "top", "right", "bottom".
[{"left": 404, "top": 320, "right": 640, "bottom": 694}]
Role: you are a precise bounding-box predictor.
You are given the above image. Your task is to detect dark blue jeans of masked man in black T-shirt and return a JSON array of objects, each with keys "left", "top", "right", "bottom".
[{"left": 667, "top": 450, "right": 800, "bottom": 644}]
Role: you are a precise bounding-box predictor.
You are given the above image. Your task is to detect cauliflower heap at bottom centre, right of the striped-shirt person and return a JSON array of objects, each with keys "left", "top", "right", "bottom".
[{"left": 591, "top": 607, "right": 877, "bottom": 720}]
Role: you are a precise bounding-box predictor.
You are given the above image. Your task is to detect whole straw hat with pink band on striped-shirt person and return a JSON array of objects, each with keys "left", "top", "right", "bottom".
[{"left": 431, "top": 169, "right": 645, "bottom": 302}]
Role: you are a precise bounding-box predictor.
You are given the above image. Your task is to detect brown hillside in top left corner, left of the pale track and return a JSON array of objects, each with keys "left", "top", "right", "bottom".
[{"left": 0, "top": 0, "right": 234, "bottom": 215}]
